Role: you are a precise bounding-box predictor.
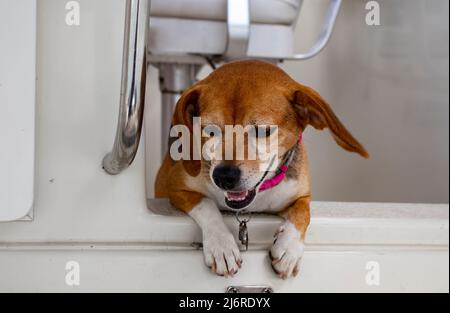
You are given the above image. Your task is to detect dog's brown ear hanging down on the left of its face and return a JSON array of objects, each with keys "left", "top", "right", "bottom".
[{"left": 172, "top": 86, "right": 201, "bottom": 177}]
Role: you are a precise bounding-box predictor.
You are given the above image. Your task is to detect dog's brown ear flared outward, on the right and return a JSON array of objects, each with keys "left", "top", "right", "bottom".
[{"left": 293, "top": 84, "right": 369, "bottom": 158}]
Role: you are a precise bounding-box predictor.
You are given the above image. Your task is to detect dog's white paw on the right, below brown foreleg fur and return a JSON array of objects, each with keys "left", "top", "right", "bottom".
[{"left": 270, "top": 222, "right": 305, "bottom": 279}]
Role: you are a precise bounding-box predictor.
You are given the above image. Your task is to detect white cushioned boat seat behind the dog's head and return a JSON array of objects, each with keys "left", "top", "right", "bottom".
[{"left": 150, "top": 0, "right": 302, "bottom": 59}]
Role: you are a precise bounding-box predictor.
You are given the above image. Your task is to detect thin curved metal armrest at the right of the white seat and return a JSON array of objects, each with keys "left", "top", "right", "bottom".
[{"left": 251, "top": 0, "right": 342, "bottom": 61}]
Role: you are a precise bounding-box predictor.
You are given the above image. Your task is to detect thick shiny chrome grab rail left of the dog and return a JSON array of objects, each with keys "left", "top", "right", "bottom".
[{"left": 103, "top": 0, "right": 150, "bottom": 175}]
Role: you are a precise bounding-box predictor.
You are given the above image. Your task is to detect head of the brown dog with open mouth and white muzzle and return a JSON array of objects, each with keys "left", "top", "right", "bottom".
[{"left": 173, "top": 61, "right": 368, "bottom": 210}]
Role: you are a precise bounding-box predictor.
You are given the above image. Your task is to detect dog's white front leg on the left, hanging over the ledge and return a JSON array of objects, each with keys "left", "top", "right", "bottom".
[{"left": 189, "top": 198, "right": 242, "bottom": 277}]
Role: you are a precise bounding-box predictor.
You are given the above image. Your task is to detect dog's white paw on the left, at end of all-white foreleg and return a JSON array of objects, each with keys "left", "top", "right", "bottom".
[{"left": 203, "top": 229, "right": 242, "bottom": 277}]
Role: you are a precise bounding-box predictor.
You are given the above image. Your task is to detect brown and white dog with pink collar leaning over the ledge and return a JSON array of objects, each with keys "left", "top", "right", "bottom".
[{"left": 156, "top": 61, "right": 368, "bottom": 279}]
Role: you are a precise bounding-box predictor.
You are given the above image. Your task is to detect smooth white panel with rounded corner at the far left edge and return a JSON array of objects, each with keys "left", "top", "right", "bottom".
[{"left": 0, "top": 0, "right": 36, "bottom": 222}]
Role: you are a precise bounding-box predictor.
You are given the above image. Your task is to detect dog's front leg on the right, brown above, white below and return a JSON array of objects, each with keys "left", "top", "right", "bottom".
[{"left": 270, "top": 197, "right": 310, "bottom": 279}]
